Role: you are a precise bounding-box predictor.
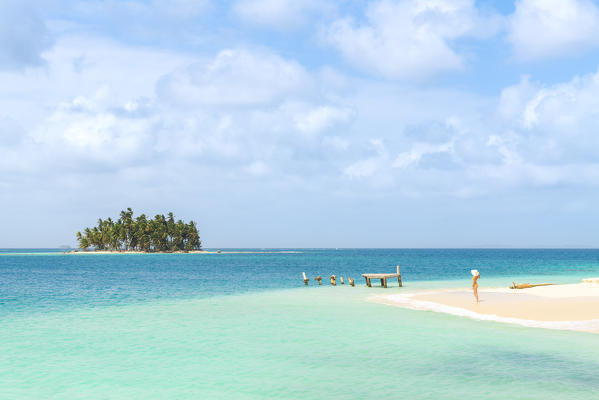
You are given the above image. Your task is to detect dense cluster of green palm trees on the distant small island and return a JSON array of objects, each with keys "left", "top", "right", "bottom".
[{"left": 77, "top": 208, "right": 202, "bottom": 252}]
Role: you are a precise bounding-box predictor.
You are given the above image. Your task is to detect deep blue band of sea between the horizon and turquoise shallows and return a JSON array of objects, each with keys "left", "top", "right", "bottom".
[{"left": 0, "top": 249, "right": 599, "bottom": 314}]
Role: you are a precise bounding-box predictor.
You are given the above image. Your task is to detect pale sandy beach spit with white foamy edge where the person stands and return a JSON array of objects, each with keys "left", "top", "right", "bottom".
[{"left": 368, "top": 283, "right": 599, "bottom": 333}]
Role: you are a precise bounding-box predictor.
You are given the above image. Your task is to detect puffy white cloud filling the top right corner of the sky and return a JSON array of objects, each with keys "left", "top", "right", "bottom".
[{"left": 508, "top": 0, "right": 599, "bottom": 60}]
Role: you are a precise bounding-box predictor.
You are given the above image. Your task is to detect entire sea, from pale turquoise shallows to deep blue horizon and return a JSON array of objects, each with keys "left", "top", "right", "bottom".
[{"left": 0, "top": 250, "right": 599, "bottom": 399}]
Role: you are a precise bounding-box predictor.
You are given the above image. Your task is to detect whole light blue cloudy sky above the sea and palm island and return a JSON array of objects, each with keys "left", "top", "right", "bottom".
[{"left": 0, "top": 0, "right": 599, "bottom": 248}]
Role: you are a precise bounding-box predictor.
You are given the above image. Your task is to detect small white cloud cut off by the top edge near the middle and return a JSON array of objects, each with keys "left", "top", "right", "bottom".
[{"left": 233, "top": 0, "right": 332, "bottom": 29}]
